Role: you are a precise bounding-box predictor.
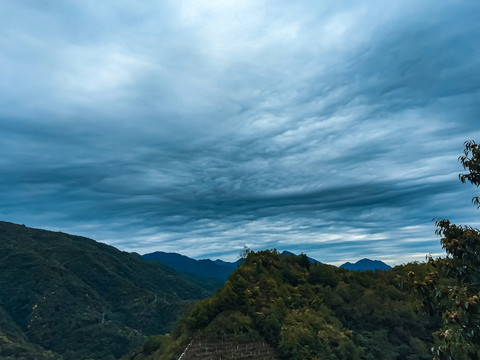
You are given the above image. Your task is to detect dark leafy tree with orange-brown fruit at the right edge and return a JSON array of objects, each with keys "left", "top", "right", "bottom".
[{"left": 409, "top": 141, "right": 480, "bottom": 360}]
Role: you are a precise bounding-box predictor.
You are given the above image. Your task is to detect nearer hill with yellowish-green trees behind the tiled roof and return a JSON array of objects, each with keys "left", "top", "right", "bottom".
[{"left": 135, "top": 250, "right": 441, "bottom": 360}]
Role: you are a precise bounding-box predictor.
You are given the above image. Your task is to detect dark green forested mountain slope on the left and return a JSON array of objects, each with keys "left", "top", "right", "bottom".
[{"left": 0, "top": 222, "right": 218, "bottom": 359}]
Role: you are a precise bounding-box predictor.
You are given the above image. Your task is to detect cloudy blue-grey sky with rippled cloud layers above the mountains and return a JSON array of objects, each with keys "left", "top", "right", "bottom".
[{"left": 0, "top": 0, "right": 480, "bottom": 264}]
